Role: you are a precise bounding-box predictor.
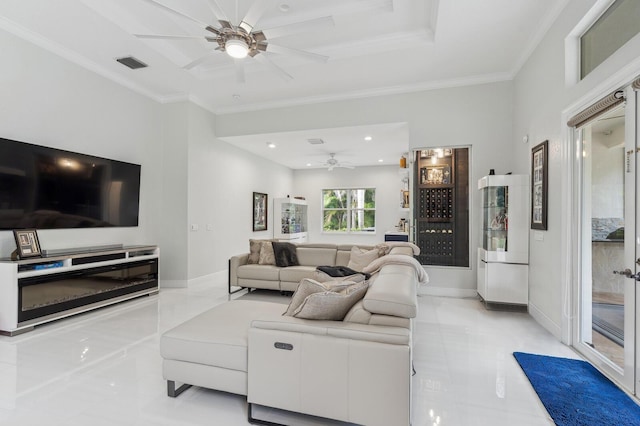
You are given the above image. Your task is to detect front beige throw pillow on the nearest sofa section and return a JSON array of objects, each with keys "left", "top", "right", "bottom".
[{"left": 292, "top": 281, "right": 369, "bottom": 321}]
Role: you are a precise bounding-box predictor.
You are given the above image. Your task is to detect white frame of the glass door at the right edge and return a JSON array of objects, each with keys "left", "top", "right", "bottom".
[{"left": 562, "top": 86, "right": 640, "bottom": 394}]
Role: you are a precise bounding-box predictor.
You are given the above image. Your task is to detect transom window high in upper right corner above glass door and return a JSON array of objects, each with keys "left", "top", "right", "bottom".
[{"left": 580, "top": 0, "right": 640, "bottom": 79}]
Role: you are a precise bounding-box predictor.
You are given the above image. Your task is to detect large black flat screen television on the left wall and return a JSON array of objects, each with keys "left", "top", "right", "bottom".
[{"left": 0, "top": 138, "right": 141, "bottom": 230}]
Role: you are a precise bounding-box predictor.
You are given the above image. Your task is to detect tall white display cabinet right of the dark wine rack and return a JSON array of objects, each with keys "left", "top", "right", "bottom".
[{"left": 478, "top": 175, "right": 529, "bottom": 305}]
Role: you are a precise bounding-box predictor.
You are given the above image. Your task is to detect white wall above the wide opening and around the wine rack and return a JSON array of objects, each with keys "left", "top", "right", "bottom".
[{"left": 216, "top": 82, "right": 517, "bottom": 295}]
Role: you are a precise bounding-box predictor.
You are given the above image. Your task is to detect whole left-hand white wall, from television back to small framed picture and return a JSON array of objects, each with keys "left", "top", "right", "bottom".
[{"left": 0, "top": 26, "right": 292, "bottom": 287}]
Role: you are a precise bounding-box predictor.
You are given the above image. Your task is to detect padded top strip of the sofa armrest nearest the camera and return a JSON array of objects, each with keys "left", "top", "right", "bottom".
[{"left": 251, "top": 315, "right": 411, "bottom": 345}]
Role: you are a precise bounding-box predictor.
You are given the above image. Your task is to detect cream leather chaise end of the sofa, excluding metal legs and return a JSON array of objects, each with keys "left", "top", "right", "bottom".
[{"left": 160, "top": 300, "right": 283, "bottom": 371}]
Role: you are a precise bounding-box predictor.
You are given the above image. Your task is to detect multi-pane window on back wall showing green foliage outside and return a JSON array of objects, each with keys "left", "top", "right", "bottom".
[{"left": 322, "top": 188, "right": 376, "bottom": 232}]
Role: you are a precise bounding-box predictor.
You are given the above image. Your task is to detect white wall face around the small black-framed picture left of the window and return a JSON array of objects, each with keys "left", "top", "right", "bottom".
[{"left": 184, "top": 104, "right": 293, "bottom": 280}]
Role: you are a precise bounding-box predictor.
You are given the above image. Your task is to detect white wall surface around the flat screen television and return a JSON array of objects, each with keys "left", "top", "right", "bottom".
[{"left": 0, "top": 30, "right": 162, "bottom": 257}]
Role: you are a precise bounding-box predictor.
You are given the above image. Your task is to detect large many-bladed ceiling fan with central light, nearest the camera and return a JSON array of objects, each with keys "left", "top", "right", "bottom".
[{"left": 134, "top": 0, "right": 334, "bottom": 82}]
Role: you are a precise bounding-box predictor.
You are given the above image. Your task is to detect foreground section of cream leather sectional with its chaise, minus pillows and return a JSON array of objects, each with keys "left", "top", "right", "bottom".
[{"left": 160, "top": 247, "right": 426, "bottom": 426}]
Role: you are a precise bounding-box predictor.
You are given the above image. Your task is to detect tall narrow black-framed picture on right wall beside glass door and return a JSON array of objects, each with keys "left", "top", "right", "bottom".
[{"left": 531, "top": 141, "right": 549, "bottom": 231}]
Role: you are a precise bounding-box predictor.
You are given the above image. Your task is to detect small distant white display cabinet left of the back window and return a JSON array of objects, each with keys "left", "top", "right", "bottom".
[{"left": 273, "top": 198, "right": 307, "bottom": 243}]
